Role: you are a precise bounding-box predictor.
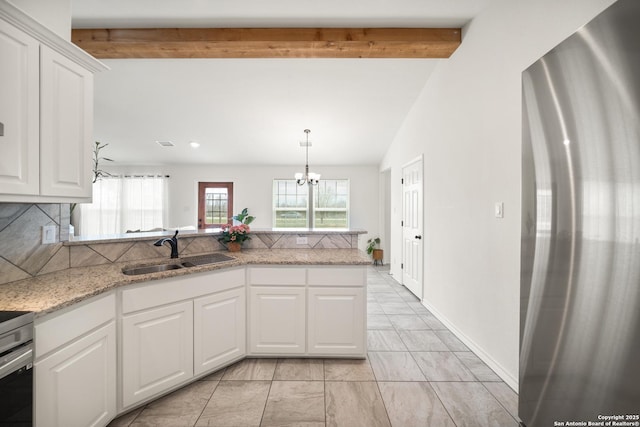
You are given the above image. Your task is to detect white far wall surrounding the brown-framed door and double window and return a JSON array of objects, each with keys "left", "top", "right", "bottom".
[{"left": 108, "top": 165, "right": 380, "bottom": 248}]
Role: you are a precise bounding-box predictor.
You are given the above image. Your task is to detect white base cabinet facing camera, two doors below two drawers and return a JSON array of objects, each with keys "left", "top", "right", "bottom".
[{"left": 248, "top": 266, "right": 367, "bottom": 357}]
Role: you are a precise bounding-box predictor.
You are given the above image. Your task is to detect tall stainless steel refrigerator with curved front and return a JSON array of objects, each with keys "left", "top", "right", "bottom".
[{"left": 519, "top": 0, "right": 640, "bottom": 427}]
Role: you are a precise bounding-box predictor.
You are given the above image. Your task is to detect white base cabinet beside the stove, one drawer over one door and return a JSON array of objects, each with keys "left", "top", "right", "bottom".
[{"left": 34, "top": 295, "right": 116, "bottom": 427}]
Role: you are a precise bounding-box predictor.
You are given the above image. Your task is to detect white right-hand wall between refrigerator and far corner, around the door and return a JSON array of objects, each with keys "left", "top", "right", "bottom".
[{"left": 380, "top": 0, "right": 613, "bottom": 388}]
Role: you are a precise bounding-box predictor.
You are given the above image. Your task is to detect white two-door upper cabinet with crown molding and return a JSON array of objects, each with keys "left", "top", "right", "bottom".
[{"left": 0, "top": 1, "right": 107, "bottom": 203}]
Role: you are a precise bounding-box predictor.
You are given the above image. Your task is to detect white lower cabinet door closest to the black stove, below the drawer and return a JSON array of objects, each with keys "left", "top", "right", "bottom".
[{"left": 34, "top": 321, "right": 116, "bottom": 427}]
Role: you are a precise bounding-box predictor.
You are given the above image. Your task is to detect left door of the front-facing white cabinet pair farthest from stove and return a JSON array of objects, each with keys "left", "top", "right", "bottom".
[{"left": 249, "top": 286, "right": 306, "bottom": 354}]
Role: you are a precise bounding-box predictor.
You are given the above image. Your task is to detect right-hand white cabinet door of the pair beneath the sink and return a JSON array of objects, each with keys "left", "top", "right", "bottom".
[{"left": 193, "top": 288, "right": 246, "bottom": 375}]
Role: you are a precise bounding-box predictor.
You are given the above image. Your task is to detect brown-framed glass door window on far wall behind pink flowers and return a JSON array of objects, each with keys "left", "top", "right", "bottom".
[{"left": 198, "top": 182, "right": 233, "bottom": 228}]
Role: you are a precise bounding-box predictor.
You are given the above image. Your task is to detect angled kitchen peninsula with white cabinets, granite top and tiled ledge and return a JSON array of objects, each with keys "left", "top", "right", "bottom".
[{"left": 0, "top": 230, "right": 370, "bottom": 426}]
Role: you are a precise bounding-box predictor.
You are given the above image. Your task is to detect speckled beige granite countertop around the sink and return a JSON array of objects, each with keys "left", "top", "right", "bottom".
[{"left": 0, "top": 249, "right": 371, "bottom": 317}]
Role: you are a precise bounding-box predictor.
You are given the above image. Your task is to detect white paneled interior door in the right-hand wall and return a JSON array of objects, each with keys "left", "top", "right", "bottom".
[{"left": 402, "top": 158, "right": 423, "bottom": 300}]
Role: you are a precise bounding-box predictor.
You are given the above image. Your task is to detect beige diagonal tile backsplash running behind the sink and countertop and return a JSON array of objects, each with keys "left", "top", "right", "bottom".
[{"left": 0, "top": 203, "right": 358, "bottom": 285}]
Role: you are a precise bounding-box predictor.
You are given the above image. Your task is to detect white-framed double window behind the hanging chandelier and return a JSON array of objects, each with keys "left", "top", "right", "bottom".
[{"left": 273, "top": 179, "right": 349, "bottom": 228}]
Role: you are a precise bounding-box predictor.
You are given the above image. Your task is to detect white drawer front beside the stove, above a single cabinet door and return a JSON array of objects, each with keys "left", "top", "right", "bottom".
[{"left": 34, "top": 293, "right": 116, "bottom": 359}]
